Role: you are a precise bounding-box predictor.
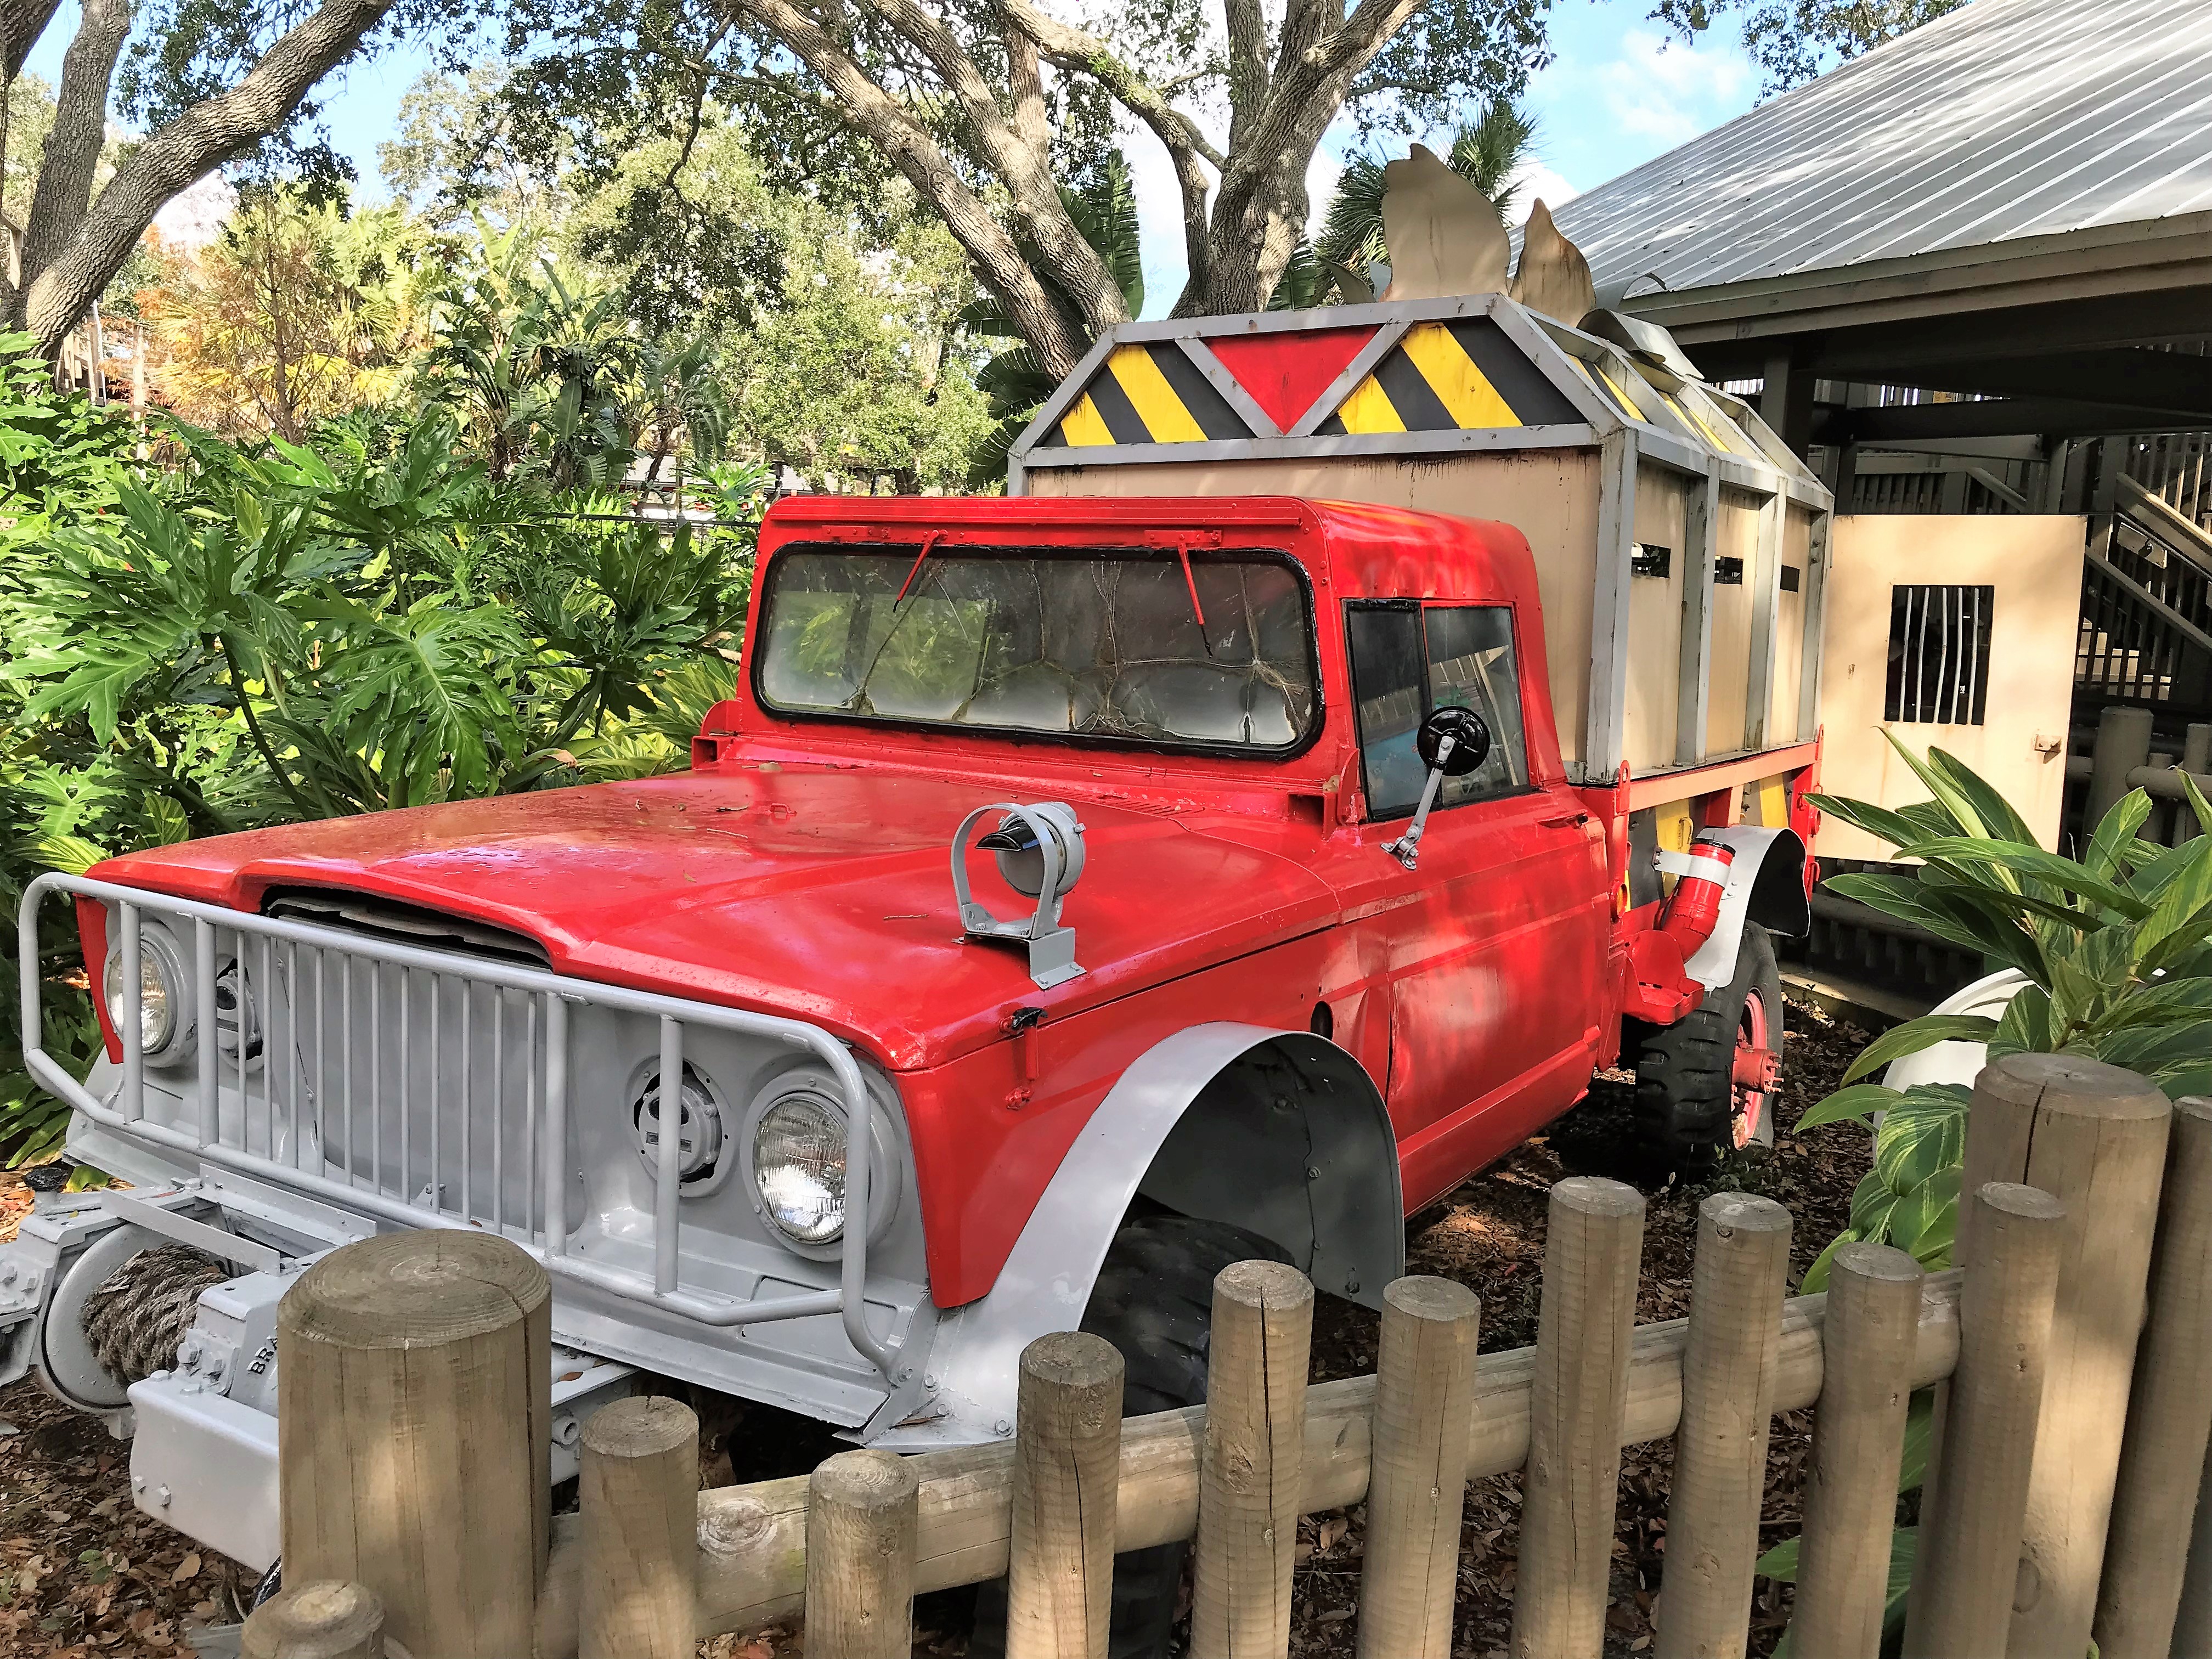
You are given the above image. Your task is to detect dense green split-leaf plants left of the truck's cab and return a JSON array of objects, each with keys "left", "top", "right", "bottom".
[{"left": 0, "top": 336, "right": 763, "bottom": 1161}]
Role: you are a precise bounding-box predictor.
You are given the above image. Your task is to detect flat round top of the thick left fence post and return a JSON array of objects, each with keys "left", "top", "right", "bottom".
[{"left": 276, "top": 1228, "right": 553, "bottom": 1350}]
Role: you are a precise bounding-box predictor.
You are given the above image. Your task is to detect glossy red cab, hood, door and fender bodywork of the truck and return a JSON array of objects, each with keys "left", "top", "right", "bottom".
[{"left": 86, "top": 498, "right": 1796, "bottom": 1307}]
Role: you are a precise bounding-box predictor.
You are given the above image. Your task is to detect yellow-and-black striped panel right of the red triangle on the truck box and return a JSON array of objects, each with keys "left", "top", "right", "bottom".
[{"left": 1314, "top": 317, "right": 1582, "bottom": 436}]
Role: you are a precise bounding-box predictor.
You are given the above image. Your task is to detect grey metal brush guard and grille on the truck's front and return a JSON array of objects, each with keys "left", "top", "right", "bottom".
[{"left": 18, "top": 872, "right": 896, "bottom": 1376}]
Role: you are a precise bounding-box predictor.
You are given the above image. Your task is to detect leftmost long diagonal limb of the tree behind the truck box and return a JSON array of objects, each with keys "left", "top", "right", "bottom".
[{"left": 739, "top": 0, "right": 1088, "bottom": 376}]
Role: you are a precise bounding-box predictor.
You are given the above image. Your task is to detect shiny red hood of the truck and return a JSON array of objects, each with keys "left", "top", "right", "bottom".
[{"left": 91, "top": 763, "right": 1336, "bottom": 1070}]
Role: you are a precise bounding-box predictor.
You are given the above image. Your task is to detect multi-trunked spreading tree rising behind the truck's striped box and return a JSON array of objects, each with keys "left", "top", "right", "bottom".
[{"left": 487, "top": 0, "right": 1546, "bottom": 376}]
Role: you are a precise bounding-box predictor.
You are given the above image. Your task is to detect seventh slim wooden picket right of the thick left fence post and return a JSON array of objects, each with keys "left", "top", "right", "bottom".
[{"left": 1652, "top": 1192, "right": 1790, "bottom": 1659}]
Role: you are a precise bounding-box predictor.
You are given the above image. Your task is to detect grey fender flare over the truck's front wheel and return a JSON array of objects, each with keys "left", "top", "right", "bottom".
[{"left": 865, "top": 1022, "right": 1404, "bottom": 1451}]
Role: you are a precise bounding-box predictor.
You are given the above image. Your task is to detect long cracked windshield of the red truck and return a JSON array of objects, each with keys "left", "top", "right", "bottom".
[{"left": 759, "top": 546, "right": 1316, "bottom": 750}]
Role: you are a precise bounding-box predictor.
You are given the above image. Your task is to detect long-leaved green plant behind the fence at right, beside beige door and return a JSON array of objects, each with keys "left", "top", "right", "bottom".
[{"left": 1798, "top": 737, "right": 2212, "bottom": 1292}]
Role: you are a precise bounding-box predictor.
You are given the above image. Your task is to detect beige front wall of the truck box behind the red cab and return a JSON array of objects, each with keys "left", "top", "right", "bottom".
[{"left": 1029, "top": 449, "right": 1601, "bottom": 765}]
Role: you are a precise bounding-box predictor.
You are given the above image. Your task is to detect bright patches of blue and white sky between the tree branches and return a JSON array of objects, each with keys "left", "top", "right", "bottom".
[{"left": 29, "top": 0, "right": 1758, "bottom": 314}]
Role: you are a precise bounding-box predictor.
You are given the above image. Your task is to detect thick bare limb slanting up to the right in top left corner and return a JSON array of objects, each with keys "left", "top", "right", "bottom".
[{"left": 24, "top": 0, "right": 394, "bottom": 352}]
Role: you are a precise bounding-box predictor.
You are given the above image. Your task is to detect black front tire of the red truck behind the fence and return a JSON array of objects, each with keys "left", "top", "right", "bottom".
[{"left": 969, "top": 1215, "right": 1285, "bottom": 1659}]
